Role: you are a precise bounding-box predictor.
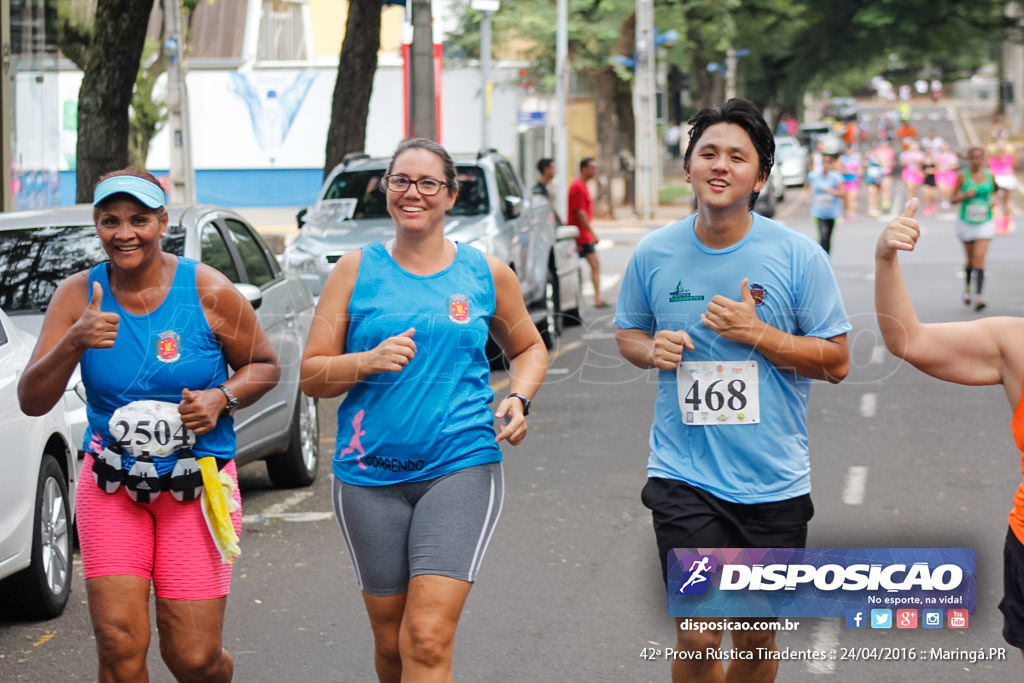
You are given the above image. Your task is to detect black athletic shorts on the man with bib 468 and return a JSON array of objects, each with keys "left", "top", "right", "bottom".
[{"left": 640, "top": 477, "right": 814, "bottom": 582}]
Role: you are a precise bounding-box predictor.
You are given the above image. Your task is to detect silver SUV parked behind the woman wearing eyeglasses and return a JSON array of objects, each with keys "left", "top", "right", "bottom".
[{"left": 282, "top": 152, "right": 582, "bottom": 347}]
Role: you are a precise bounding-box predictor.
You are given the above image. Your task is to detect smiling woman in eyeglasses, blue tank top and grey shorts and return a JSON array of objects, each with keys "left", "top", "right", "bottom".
[{"left": 301, "top": 138, "right": 548, "bottom": 681}]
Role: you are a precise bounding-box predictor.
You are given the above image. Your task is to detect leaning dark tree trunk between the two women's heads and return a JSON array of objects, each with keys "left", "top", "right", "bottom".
[{"left": 324, "top": 0, "right": 381, "bottom": 177}]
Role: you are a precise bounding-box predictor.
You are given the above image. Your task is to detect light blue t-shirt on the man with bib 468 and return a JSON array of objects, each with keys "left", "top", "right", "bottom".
[{"left": 614, "top": 213, "right": 850, "bottom": 504}]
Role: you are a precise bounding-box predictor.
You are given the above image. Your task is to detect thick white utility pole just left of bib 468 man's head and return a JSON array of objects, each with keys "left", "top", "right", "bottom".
[{"left": 633, "top": 0, "right": 660, "bottom": 219}]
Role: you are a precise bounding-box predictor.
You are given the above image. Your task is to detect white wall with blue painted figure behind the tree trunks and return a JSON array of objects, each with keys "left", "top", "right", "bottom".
[{"left": 51, "top": 63, "right": 519, "bottom": 170}]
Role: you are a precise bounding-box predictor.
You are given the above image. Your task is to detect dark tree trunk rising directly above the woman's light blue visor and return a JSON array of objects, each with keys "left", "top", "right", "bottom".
[{"left": 75, "top": 0, "right": 153, "bottom": 202}]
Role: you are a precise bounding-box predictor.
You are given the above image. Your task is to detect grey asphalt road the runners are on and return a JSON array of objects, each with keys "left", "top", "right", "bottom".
[{"left": 0, "top": 104, "right": 1024, "bottom": 683}]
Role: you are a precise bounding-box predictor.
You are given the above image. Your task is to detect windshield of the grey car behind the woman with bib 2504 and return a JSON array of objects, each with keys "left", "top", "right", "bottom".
[{"left": 0, "top": 224, "right": 184, "bottom": 314}]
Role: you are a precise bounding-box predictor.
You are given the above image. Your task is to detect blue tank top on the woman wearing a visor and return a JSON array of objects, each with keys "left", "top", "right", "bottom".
[{"left": 81, "top": 257, "right": 234, "bottom": 475}]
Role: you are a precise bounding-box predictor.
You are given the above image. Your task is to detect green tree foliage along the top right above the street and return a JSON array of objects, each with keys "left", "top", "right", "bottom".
[{"left": 450, "top": 0, "right": 1014, "bottom": 137}]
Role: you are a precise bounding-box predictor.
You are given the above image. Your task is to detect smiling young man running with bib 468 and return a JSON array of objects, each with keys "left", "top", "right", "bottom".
[{"left": 614, "top": 99, "right": 850, "bottom": 683}]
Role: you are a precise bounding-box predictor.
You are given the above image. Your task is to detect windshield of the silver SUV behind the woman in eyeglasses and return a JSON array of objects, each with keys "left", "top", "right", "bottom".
[{"left": 323, "top": 166, "right": 489, "bottom": 220}]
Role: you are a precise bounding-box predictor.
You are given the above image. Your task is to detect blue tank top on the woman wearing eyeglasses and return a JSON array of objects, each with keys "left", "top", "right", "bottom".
[{"left": 333, "top": 243, "right": 502, "bottom": 486}]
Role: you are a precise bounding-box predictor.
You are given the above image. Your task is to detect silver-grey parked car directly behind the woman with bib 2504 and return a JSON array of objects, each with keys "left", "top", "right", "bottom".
[{"left": 0, "top": 205, "right": 319, "bottom": 486}]
